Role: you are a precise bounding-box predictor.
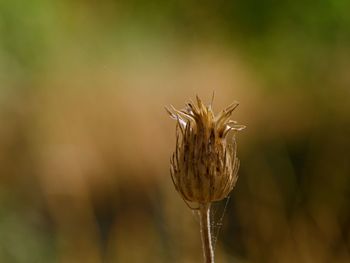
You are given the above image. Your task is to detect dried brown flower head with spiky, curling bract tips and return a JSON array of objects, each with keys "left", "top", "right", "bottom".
[{"left": 167, "top": 96, "right": 245, "bottom": 208}]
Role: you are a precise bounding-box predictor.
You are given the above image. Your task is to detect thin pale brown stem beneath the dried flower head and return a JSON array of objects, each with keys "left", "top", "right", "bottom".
[{"left": 199, "top": 203, "right": 214, "bottom": 263}]
